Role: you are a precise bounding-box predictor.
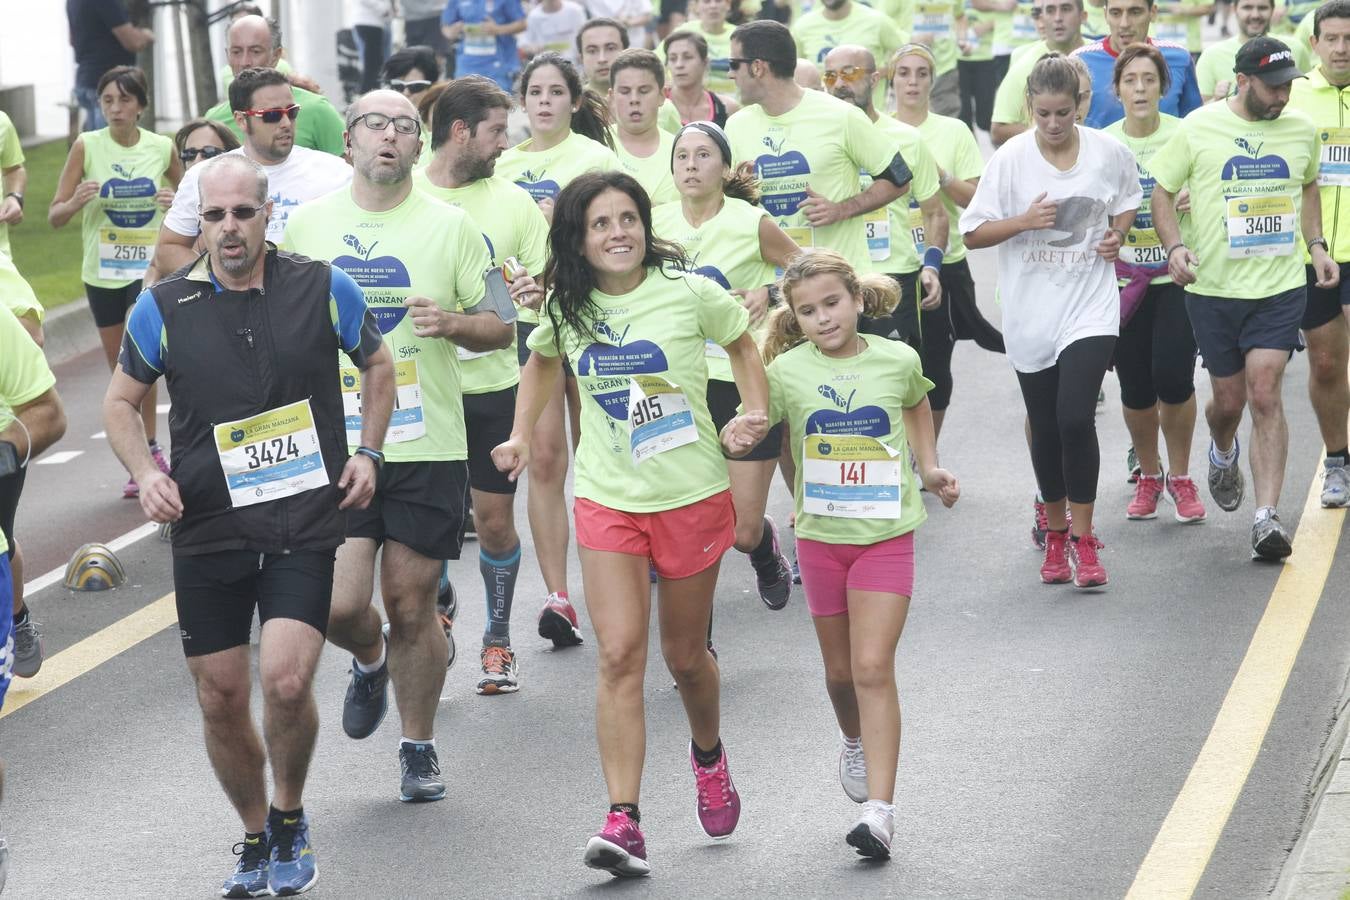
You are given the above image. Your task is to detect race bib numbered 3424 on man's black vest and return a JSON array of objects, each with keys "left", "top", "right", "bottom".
[{"left": 215, "top": 399, "right": 328, "bottom": 509}]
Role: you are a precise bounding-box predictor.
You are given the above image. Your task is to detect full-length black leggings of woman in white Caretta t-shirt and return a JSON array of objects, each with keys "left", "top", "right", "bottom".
[{"left": 1017, "top": 335, "right": 1115, "bottom": 503}]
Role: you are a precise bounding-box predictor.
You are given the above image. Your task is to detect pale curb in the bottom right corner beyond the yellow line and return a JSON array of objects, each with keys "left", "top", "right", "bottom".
[{"left": 1270, "top": 684, "right": 1350, "bottom": 900}]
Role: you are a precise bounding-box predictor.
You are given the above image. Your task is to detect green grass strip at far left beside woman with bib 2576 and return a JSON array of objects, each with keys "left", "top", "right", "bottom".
[{"left": 9, "top": 140, "right": 84, "bottom": 309}]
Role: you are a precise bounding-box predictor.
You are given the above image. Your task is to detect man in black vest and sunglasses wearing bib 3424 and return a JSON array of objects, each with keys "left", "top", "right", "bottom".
[{"left": 103, "top": 155, "right": 394, "bottom": 897}]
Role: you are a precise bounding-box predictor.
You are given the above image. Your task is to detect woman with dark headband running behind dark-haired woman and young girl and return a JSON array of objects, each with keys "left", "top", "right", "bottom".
[{"left": 652, "top": 121, "right": 799, "bottom": 610}]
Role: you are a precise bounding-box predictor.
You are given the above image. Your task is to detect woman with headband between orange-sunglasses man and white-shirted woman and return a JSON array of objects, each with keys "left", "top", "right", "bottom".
[{"left": 890, "top": 45, "right": 1006, "bottom": 440}]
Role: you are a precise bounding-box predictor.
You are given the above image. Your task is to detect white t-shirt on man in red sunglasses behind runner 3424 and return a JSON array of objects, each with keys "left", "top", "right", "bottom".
[{"left": 165, "top": 147, "right": 351, "bottom": 244}]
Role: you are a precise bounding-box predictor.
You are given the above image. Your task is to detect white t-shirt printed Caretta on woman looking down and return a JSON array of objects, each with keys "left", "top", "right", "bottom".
[{"left": 961, "top": 125, "right": 1143, "bottom": 372}]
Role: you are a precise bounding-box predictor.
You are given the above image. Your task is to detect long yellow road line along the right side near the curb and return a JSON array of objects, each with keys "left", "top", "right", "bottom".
[{"left": 1126, "top": 469, "right": 1346, "bottom": 900}]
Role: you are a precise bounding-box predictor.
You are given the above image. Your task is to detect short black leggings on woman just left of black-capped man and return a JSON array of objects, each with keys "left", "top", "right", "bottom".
[{"left": 1115, "top": 282, "right": 1195, "bottom": 409}]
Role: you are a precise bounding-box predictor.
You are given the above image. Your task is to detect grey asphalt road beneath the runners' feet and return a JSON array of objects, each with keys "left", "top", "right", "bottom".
[{"left": 0, "top": 254, "right": 1350, "bottom": 899}]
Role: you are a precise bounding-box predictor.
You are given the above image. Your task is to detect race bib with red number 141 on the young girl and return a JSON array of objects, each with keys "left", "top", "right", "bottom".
[{"left": 802, "top": 434, "right": 900, "bottom": 519}]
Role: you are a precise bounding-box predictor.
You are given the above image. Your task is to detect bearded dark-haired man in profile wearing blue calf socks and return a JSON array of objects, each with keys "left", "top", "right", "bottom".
[{"left": 413, "top": 76, "right": 553, "bottom": 694}]
